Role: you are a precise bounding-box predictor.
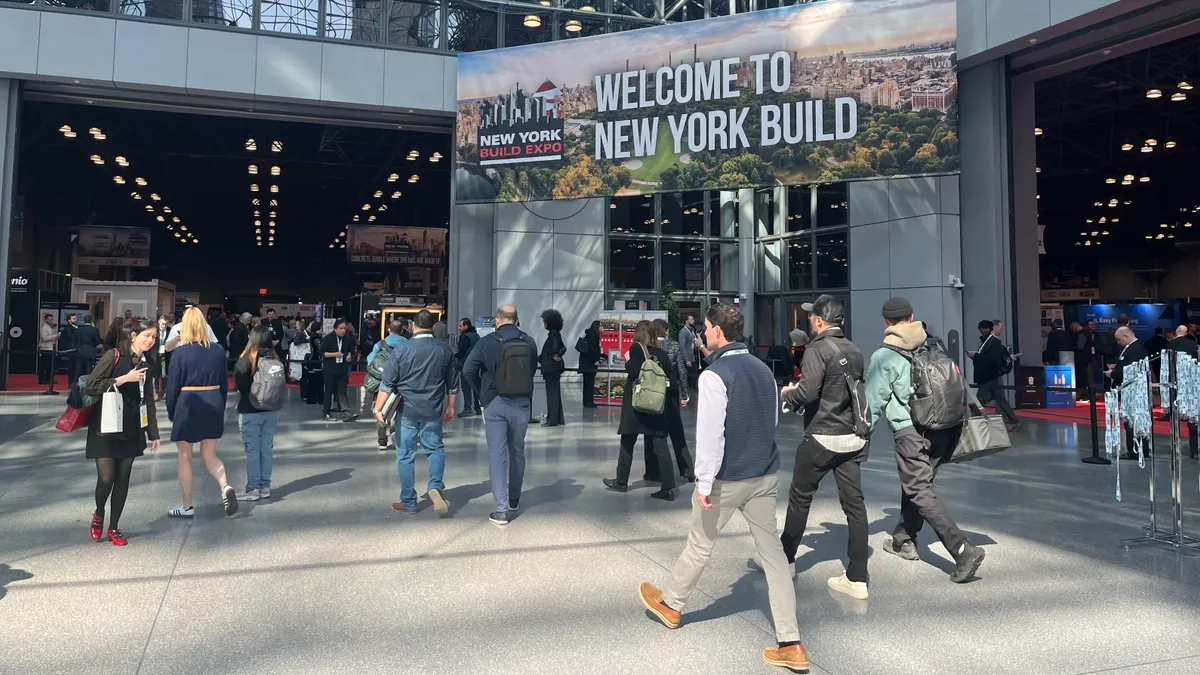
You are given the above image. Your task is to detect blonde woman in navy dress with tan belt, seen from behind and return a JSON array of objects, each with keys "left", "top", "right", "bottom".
[{"left": 167, "top": 307, "right": 238, "bottom": 518}]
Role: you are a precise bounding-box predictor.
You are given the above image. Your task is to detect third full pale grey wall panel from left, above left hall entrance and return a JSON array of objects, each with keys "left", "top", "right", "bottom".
[{"left": 187, "top": 28, "right": 258, "bottom": 95}]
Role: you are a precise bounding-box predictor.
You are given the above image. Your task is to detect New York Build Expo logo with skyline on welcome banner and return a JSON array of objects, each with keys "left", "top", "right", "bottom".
[{"left": 479, "top": 79, "right": 565, "bottom": 167}]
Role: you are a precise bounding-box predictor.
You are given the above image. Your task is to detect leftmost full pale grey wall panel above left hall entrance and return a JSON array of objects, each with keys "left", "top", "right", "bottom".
[{"left": 37, "top": 12, "right": 116, "bottom": 82}]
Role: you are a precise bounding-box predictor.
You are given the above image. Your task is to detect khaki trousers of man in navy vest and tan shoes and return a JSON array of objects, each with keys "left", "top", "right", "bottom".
[{"left": 662, "top": 473, "right": 800, "bottom": 643}]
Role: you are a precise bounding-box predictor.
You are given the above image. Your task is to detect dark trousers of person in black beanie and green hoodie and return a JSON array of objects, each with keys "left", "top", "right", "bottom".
[{"left": 892, "top": 425, "right": 967, "bottom": 556}]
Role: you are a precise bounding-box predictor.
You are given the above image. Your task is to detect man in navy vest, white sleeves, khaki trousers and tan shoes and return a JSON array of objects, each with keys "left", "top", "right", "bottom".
[{"left": 638, "top": 304, "right": 809, "bottom": 671}]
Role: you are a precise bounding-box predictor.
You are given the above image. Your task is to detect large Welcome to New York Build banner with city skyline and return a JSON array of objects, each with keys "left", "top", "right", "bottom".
[{"left": 456, "top": 0, "right": 959, "bottom": 203}]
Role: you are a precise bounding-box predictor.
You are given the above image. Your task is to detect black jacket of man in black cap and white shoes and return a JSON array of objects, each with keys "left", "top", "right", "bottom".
[{"left": 782, "top": 328, "right": 865, "bottom": 436}]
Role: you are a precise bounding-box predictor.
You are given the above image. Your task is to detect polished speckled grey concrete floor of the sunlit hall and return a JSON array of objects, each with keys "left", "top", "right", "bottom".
[{"left": 0, "top": 389, "right": 1200, "bottom": 675}]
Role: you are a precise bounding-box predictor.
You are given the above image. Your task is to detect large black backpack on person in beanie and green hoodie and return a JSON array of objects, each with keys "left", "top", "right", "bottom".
[{"left": 883, "top": 340, "right": 967, "bottom": 431}]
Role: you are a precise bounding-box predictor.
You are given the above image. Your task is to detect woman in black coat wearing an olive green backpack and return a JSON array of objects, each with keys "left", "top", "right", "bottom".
[{"left": 604, "top": 321, "right": 676, "bottom": 502}]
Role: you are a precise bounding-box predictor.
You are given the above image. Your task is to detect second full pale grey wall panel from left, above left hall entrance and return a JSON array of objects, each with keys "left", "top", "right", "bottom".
[{"left": 113, "top": 22, "right": 191, "bottom": 89}]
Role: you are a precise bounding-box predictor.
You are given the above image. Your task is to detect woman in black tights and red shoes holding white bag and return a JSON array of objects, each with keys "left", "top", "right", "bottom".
[{"left": 86, "top": 318, "right": 158, "bottom": 546}]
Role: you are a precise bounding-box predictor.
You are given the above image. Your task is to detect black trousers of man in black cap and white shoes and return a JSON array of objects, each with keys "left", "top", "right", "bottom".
[{"left": 780, "top": 436, "right": 870, "bottom": 583}]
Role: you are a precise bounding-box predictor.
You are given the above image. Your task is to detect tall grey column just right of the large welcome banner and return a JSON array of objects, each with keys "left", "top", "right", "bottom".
[{"left": 959, "top": 60, "right": 1013, "bottom": 379}]
